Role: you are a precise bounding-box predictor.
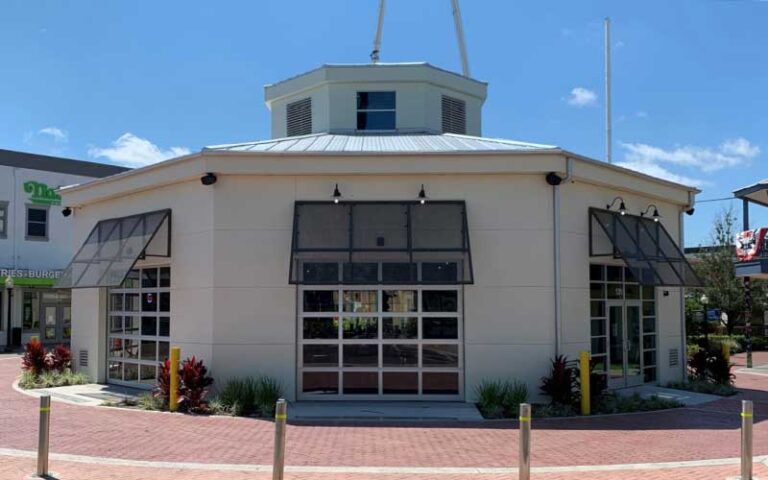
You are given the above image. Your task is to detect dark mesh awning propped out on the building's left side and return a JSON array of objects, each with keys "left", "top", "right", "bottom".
[{"left": 56, "top": 210, "right": 171, "bottom": 288}]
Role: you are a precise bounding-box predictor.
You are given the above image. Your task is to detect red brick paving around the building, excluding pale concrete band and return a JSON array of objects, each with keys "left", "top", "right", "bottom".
[{"left": 0, "top": 352, "right": 768, "bottom": 479}]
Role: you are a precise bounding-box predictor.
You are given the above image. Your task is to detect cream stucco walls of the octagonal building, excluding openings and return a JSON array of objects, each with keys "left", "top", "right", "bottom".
[{"left": 66, "top": 160, "right": 681, "bottom": 401}]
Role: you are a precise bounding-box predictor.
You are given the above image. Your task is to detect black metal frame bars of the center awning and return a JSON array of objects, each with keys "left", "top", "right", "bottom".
[{"left": 288, "top": 200, "right": 474, "bottom": 285}]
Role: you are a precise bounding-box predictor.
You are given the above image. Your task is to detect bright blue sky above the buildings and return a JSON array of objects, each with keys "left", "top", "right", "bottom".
[{"left": 0, "top": 0, "right": 768, "bottom": 246}]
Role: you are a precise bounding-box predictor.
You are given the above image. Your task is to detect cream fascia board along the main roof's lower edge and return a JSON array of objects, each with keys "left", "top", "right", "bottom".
[{"left": 60, "top": 149, "right": 698, "bottom": 207}]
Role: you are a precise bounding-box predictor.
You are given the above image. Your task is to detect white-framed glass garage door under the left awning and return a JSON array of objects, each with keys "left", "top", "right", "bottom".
[{"left": 107, "top": 266, "right": 171, "bottom": 388}]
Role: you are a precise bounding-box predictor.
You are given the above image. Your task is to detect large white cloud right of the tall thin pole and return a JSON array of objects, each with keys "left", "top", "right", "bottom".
[{"left": 618, "top": 137, "right": 760, "bottom": 186}]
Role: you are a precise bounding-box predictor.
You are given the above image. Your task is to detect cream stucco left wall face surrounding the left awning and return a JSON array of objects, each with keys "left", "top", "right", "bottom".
[{"left": 71, "top": 180, "right": 215, "bottom": 381}]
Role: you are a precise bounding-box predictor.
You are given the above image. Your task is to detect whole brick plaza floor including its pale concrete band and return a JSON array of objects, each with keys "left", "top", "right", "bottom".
[{"left": 0, "top": 352, "right": 768, "bottom": 480}]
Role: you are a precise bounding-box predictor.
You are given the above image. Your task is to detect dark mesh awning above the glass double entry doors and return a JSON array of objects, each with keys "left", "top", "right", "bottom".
[{"left": 589, "top": 208, "right": 701, "bottom": 287}]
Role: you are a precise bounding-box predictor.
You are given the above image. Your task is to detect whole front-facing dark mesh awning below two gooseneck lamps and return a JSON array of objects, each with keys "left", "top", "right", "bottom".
[{"left": 290, "top": 201, "right": 472, "bottom": 284}]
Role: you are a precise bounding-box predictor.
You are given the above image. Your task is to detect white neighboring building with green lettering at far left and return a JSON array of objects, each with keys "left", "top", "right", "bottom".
[{"left": 0, "top": 150, "right": 126, "bottom": 348}]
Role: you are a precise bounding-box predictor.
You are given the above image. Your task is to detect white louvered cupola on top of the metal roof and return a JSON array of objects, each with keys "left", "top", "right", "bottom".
[{"left": 264, "top": 63, "right": 488, "bottom": 138}]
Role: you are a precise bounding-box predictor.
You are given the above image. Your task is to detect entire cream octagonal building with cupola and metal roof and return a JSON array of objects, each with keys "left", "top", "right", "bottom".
[{"left": 60, "top": 64, "right": 698, "bottom": 401}]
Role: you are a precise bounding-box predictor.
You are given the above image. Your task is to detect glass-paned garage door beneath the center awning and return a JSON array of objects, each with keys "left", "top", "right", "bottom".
[{"left": 298, "top": 286, "right": 463, "bottom": 400}]
